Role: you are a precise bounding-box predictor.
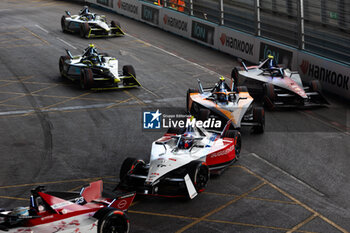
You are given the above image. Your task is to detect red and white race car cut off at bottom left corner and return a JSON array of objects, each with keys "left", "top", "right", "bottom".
[{"left": 0, "top": 180, "right": 135, "bottom": 233}]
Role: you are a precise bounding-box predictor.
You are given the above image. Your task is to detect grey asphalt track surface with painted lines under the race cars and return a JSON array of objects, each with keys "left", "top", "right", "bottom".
[{"left": 0, "top": 0, "right": 350, "bottom": 232}]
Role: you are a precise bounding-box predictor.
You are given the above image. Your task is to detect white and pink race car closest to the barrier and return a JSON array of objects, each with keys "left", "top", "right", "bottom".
[{"left": 231, "top": 55, "right": 328, "bottom": 109}]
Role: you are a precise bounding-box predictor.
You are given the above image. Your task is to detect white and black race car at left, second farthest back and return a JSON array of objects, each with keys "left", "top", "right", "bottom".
[{"left": 59, "top": 44, "right": 141, "bottom": 90}]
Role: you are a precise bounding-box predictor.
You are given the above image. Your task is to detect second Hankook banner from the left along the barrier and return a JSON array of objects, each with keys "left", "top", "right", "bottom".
[{"left": 159, "top": 10, "right": 191, "bottom": 38}]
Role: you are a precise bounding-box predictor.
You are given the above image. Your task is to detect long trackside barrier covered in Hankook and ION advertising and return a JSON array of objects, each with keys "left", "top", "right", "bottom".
[{"left": 87, "top": 0, "right": 350, "bottom": 100}]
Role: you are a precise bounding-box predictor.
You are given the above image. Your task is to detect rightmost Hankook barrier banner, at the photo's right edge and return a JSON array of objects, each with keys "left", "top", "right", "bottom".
[{"left": 298, "top": 52, "right": 350, "bottom": 100}]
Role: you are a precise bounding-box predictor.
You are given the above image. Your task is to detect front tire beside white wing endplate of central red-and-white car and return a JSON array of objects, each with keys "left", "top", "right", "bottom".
[{"left": 188, "top": 161, "right": 210, "bottom": 193}]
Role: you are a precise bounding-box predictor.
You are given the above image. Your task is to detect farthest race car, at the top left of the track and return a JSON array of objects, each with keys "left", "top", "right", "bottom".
[{"left": 61, "top": 6, "right": 124, "bottom": 38}]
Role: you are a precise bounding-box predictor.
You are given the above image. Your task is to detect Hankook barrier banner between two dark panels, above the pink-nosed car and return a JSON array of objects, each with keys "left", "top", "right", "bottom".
[{"left": 216, "top": 27, "right": 260, "bottom": 63}]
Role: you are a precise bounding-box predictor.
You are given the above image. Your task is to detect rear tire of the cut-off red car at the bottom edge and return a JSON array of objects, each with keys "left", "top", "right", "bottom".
[{"left": 94, "top": 207, "right": 130, "bottom": 233}]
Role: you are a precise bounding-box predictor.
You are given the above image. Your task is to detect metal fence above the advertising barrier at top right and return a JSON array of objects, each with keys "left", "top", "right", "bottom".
[{"left": 147, "top": 0, "right": 350, "bottom": 64}]
